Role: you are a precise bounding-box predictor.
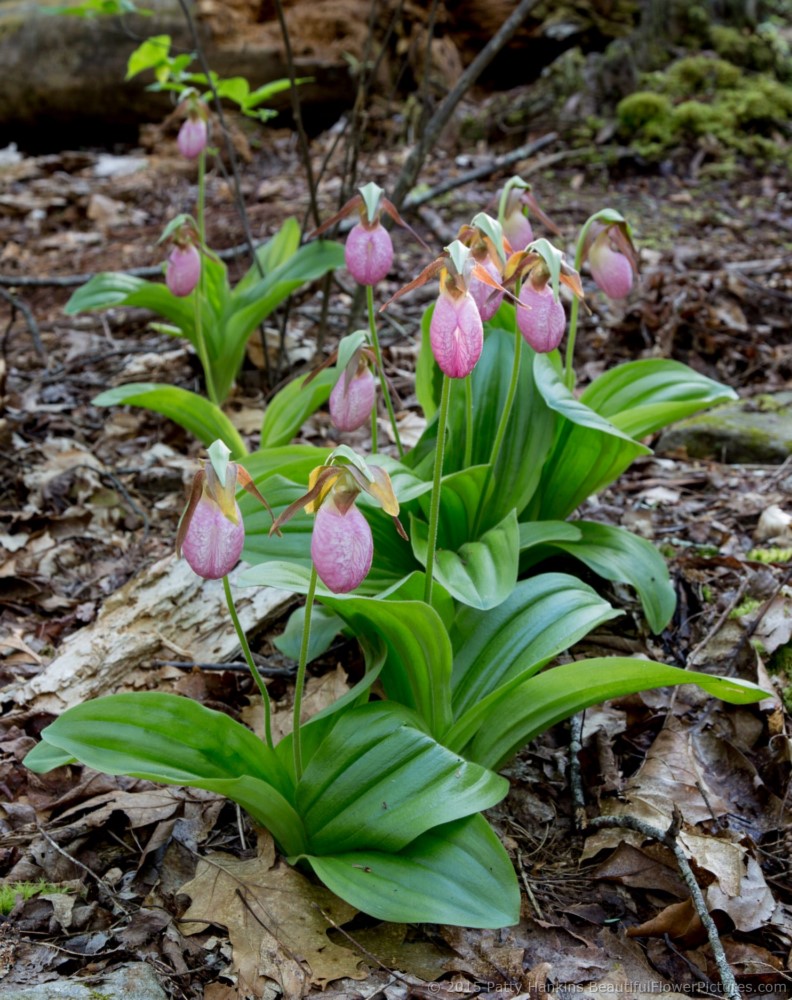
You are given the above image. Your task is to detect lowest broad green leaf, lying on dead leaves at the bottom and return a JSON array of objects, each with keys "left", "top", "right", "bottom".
[{"left": 304, "top": 815, "right": 520, "bottom": 928}]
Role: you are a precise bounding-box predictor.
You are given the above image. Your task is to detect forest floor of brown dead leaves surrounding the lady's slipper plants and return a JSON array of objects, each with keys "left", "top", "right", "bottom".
[{"left": 0, "top": 105, "right": 792, "bottom": 1000}]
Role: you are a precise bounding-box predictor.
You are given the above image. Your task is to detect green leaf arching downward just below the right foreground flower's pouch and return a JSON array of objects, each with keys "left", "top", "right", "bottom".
[{"left": 321, "top": 595, "right": 451, "bottom": 738}]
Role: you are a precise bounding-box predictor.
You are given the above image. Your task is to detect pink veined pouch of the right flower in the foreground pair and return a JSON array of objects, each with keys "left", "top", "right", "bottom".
[{"left": 311, "top": 498, "right": 374, "bottom": 594}]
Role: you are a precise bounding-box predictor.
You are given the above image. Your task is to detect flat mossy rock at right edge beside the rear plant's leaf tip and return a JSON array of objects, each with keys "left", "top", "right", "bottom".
[{"left": 656, "top": 392, "right": 792, "bottom": 465}]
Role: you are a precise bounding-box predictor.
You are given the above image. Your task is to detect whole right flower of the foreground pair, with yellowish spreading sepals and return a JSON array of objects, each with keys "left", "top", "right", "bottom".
[{"left": 272, "top": 445, "right": 407, "bottom": 594}]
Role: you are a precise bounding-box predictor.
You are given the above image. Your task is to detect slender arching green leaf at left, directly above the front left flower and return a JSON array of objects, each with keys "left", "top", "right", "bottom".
[{"left": 92, "top": 382, "right": 247, "bottom": 460}]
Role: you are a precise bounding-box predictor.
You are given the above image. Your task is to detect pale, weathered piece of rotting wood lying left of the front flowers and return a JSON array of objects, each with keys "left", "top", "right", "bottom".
[{"left": 5, "top": 556, "right": 292, "bottom": 714}]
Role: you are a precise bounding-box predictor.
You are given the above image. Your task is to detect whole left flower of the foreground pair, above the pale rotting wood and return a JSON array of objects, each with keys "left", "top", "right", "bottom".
[{"left": 176, "top": 441, "right": 270, "bottom": 580}]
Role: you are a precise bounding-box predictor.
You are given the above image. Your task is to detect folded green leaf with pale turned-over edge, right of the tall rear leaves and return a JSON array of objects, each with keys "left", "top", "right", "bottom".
[{"left": 523, "top": 354, "right": 650, "bottom": 520}]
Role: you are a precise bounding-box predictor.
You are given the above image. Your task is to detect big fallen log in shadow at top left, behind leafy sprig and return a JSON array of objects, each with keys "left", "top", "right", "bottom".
[{"left": 0, "top": 0, "right": 353, "bottom": 138}]
